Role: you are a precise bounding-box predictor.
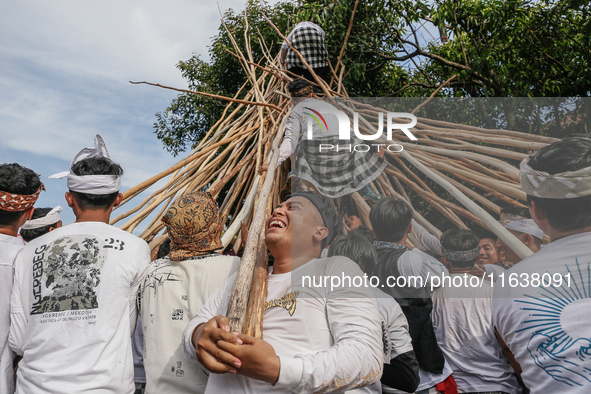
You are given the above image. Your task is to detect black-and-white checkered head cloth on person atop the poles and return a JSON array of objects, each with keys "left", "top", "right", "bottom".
[{"left": 285, "top": 27, "right": 328, "bottom": 69}]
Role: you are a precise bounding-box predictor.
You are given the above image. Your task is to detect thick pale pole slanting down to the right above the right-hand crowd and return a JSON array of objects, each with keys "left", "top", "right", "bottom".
[{"left": 401, "top": 151, "right": 532, "bottom": 259}]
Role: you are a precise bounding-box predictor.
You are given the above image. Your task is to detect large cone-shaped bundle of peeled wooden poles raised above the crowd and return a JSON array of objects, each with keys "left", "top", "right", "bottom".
[{"left": 111, "top": 14, "right": 556, "bottom": 337}]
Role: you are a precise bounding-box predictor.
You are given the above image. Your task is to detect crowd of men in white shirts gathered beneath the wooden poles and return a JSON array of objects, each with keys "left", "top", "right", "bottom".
[{"left": 0, "top": 126, "right": 591, "bottom": 394}]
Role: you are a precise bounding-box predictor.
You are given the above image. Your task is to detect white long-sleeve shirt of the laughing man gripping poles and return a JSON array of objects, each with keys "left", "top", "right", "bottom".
[{"left": 183, "top": 256, "right": 383, "bottom": 394}]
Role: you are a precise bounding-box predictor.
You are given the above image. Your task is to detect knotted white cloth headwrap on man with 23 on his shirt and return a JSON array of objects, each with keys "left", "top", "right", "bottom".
[{"left": 49, "top": 134, "right": 121, "bottom": 195}]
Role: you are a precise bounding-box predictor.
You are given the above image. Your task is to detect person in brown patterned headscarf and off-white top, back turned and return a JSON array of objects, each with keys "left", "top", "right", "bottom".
[{"left": 139, "top": 191, "right": 240, "bottom": 394}]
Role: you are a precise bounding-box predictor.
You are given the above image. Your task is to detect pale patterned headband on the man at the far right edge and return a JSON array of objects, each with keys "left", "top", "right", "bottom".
[{"left": 519, "top": 158, "right": 591, "bottom": 200}]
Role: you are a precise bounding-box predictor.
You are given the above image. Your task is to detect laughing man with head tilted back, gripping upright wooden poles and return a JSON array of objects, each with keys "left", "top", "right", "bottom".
[{"left": 183, "top": 193, "right": 383, "bottom": 394}]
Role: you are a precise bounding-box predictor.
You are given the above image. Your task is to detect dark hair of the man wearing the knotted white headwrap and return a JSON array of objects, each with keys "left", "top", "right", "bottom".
[{"left": 70, "top": 157, "right": 123, "bottom": 209}]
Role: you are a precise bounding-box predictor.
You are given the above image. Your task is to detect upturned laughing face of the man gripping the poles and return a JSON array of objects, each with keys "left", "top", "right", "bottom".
[{"left": 265, "top": 196, "right": 328, "bottom": 252}]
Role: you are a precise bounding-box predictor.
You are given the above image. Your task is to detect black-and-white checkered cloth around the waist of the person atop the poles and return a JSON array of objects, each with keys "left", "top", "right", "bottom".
[{"left": 293, "top": 136, "right": 388, "bottom": 198}]
